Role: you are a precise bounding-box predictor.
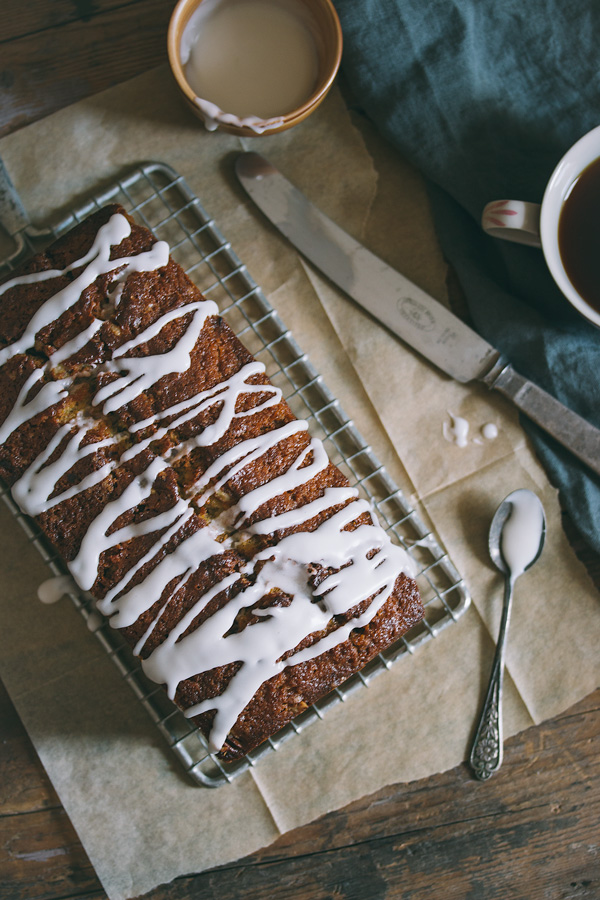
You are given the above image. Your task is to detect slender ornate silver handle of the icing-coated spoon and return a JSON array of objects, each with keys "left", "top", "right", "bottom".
[{"left": 469, "top": 576, "right": 513, "bottom": 781}]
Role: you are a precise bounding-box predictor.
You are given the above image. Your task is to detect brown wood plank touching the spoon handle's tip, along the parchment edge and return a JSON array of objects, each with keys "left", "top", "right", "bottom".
[{"left": 244, "top": 691, "right": 600, "bottom": 860}]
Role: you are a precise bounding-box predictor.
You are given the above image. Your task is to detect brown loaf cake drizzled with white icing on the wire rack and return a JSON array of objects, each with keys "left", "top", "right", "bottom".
[{"left": 0, "top": 206, "right": 423, "bottom": 759}]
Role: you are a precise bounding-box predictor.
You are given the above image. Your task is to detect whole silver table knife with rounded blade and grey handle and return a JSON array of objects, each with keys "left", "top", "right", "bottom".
[{"left": 235, "top": 152, "right": 600, "bottom": 475}]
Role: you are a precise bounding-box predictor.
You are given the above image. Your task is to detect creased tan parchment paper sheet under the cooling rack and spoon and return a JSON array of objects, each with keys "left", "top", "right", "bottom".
[{"left": 0, "top": 67, "right": 600, "bottom": 900}]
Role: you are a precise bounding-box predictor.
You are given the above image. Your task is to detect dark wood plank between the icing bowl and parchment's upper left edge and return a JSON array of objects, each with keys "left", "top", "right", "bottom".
[{"left": 0, "top": 0, "right": 173, "bottom": 136}]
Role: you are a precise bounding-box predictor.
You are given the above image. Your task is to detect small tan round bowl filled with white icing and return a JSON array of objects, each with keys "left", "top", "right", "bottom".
[{"left": 168, "top": 0, "right": 342, "bottom": 137}]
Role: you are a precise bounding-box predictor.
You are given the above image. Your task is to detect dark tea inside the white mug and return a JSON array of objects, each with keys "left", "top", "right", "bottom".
[{"left": 558, "top": 159, "right": 600, "bottom": 312}]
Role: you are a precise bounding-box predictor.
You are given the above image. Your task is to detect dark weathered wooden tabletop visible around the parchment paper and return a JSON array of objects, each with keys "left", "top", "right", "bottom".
[{"left": 0, "top": 0, "right": 600, "bottom": 900}]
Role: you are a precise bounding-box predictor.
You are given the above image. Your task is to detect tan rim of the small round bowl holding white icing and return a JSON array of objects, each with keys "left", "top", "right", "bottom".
[{"left": 167, "top": 0, "right": 343, "bottom": 133}]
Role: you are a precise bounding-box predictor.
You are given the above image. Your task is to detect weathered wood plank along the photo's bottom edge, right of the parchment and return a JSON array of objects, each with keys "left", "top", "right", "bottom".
[{"left": 163, "top": 805, "right": 600, "bottom": 900}]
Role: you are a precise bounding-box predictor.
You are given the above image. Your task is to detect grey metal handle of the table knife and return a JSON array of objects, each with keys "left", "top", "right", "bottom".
[{"left": 482, "top": 363, "right": 600, "bottom": 475}]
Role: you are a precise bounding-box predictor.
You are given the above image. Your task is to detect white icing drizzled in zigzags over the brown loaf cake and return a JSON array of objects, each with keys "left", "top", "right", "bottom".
[{"left": 0, "top": 215, "right": 414, "bottom": 750}]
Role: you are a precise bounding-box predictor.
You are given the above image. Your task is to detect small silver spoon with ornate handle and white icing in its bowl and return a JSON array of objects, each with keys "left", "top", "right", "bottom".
[{"left": 470, "top": 489, "right": 546, "bottom": 781}]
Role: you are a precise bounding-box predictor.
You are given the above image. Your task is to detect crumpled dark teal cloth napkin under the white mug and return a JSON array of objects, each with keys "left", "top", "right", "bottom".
[{"left": 335, "top": 0, "right": 600, "bottom": 552}]
